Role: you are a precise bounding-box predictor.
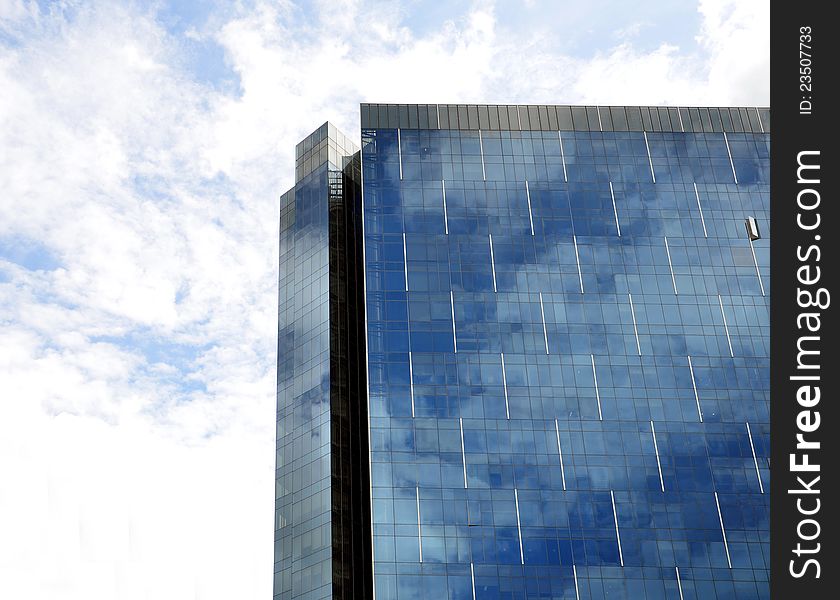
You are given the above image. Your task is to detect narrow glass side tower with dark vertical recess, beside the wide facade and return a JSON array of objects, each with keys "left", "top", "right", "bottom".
[{"left": 274, "top": 123, "right": 371, "bottom": 600}]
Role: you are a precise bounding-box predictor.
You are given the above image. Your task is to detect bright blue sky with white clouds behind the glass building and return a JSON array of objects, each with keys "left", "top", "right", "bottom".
[{"left": 0, "top": 0, "right": 770, "bottom": 600}]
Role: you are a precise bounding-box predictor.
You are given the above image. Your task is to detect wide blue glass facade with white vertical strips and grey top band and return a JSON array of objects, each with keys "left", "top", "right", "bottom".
[{"left": 360, "top": 105, "right": 770, "bottom": 600}]
